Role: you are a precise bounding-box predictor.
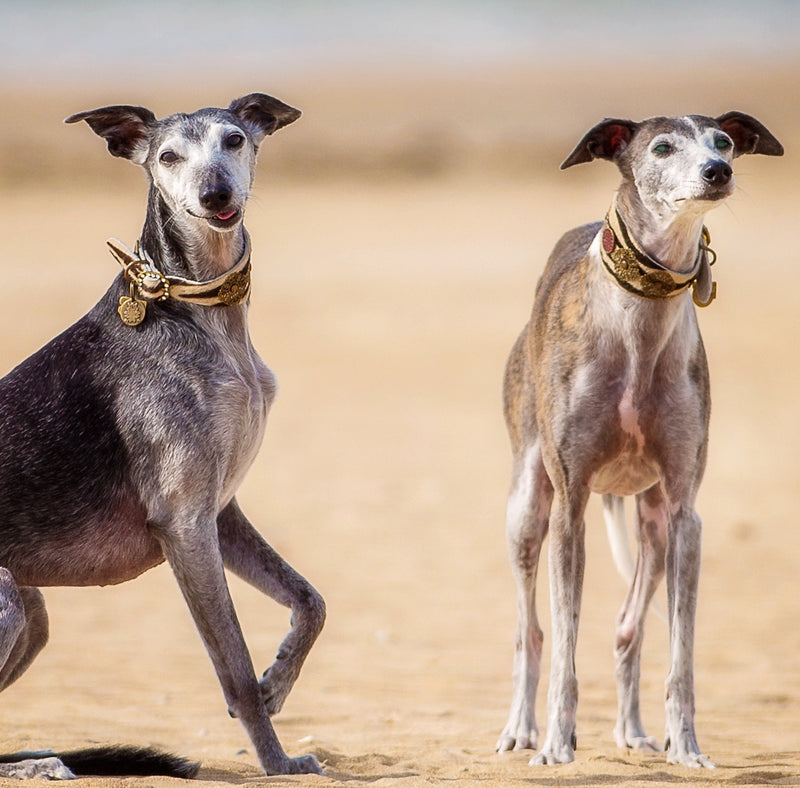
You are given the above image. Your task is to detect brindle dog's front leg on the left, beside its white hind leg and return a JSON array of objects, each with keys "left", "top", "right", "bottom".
[{"left": 531, "top": 485, "right": 589, "bottom": 765}]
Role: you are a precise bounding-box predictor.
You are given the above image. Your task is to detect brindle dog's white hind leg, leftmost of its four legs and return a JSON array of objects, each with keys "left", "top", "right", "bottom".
[{"left": 497, "top": 443, "right": 553, "bottom": 752}]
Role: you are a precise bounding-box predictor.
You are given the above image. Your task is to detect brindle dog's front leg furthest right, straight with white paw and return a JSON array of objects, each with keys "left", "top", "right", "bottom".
[{"left": 666, "top": 504, "right": 714, "bottom": 769}]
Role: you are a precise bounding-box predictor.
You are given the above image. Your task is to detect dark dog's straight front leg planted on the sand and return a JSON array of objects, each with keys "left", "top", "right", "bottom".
[{"left": 159, "top": 515, "right": 321, "bottom": 774}]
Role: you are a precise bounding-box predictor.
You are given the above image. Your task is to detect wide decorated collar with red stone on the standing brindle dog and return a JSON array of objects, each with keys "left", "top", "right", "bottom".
[{"left": 600, "top": 199, "right": 717, "bottom": 306}]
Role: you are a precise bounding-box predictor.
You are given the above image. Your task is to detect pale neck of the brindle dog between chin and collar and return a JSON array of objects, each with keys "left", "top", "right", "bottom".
[{"left": 617, "top": 180, "right": 711, "bottom": 273}]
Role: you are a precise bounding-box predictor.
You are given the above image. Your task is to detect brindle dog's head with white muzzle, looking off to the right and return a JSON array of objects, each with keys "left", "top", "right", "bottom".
[{"left": 561, "top": 112, "right": 783, "bottom": 219}]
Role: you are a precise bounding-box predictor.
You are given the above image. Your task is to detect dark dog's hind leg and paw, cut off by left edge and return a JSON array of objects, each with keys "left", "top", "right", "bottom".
[{"left": 0, "top": 567, "right": 75, "bottom": 780}]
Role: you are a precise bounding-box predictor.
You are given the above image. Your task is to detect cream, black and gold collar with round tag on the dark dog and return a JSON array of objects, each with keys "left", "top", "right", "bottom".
[{"left": 107, "top": 230, "right": 250, "bottom": 326}]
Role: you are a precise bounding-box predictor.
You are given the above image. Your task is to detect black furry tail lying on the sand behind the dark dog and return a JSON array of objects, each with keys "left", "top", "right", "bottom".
[{"left": 0, "top": 745, "right": 200, "bottom": 780}]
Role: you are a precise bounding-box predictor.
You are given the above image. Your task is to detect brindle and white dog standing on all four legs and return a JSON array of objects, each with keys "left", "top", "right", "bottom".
[{"left": 497, "top": 112, "right": 783, "bottom": 768}]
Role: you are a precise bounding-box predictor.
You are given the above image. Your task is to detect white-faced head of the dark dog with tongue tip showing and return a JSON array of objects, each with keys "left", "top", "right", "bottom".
[{"left": 65, "top": 93, "right": 300, "bottom": 232}]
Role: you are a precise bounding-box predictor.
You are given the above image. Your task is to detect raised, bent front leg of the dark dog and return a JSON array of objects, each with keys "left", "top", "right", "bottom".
[{"left": 217, "top": 500, "right": 325, "bottom": 715}]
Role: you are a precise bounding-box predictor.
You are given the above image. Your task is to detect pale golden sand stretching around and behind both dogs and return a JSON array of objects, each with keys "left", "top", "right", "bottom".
[{"left": 0, "top": 67, "right": 800, "bottom": 788}]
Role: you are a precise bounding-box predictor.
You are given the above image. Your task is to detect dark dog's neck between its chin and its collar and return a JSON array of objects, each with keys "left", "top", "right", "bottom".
[{"left": 141, "top": 185, "right": 245, "bottom": 281}]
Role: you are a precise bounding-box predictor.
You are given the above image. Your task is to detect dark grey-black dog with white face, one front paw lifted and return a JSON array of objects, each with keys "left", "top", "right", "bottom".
[{"left": 0, "top": 93, "right": 325, "bottom": 777}]
